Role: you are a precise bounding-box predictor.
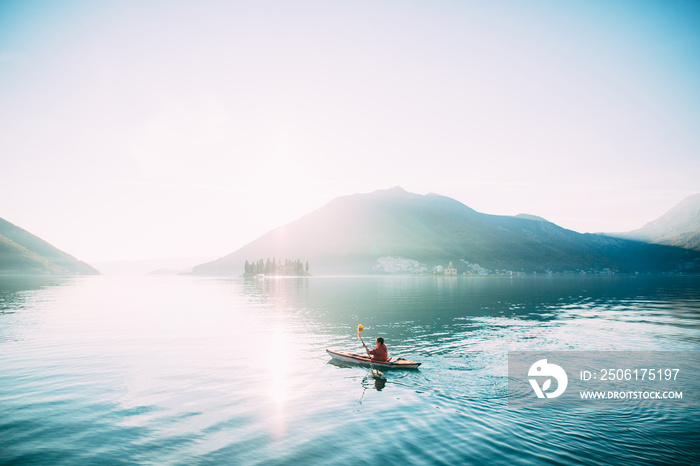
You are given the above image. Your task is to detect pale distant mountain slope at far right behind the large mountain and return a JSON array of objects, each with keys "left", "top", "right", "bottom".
[{"left": 615, "top": 194, "right": 700, "bottom": 251}]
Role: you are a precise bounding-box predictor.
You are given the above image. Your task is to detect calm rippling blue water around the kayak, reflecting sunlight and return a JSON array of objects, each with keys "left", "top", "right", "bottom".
[{"left": 0, "top": 276, "right": 700, "bottom": 464}]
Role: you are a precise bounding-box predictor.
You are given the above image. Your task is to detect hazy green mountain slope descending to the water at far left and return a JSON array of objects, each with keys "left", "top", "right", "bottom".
[{"left": 0, "top": 218, "right": 100, "bottom": 275}]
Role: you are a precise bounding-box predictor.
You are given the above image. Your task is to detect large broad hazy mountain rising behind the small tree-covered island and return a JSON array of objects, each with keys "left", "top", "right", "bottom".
[{"left": 193, "top": 187, "right": 700, "bottom": 275}]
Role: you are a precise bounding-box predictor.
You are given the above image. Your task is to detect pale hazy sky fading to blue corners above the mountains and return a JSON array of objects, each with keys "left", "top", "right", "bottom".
[{"left": 0, "top": 0, "right": 700, "bottom": 262}]
